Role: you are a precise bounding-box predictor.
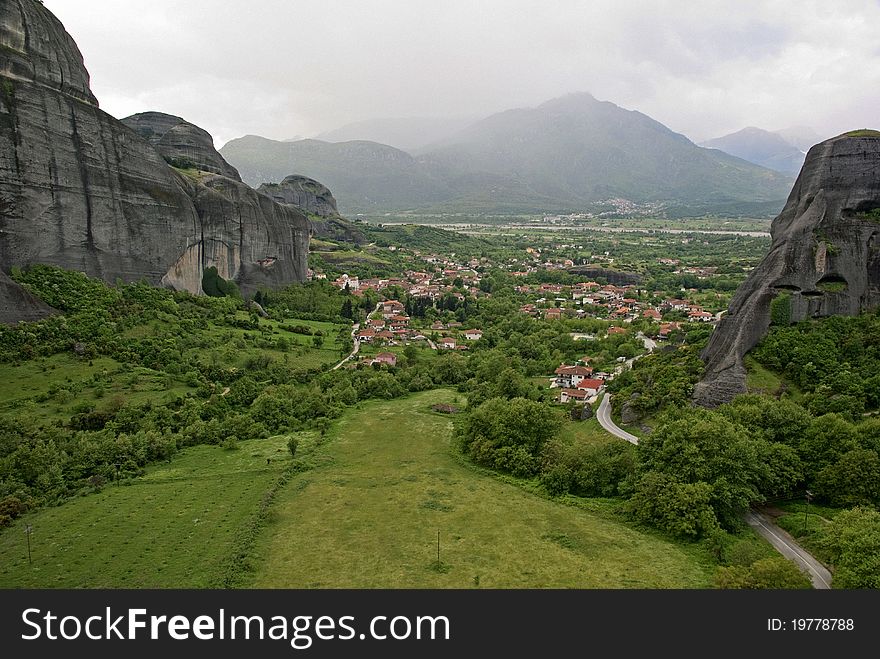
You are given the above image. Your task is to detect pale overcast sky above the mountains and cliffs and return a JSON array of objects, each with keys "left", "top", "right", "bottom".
[{"left": 44, "top": 0, "right": 880, "bottom": 147}]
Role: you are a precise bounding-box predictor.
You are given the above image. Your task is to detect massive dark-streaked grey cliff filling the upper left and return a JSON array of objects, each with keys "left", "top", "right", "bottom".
[{"left": 0, "top": 0, "right": 309, "bottom": 321}]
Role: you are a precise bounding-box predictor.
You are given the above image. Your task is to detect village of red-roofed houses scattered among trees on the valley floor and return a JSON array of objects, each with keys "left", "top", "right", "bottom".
[{"left": 312, "top": 237, "right": 723, "bottom": 404}]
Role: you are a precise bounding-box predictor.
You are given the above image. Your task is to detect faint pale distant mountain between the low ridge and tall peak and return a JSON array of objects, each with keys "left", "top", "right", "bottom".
[{"left": 317, "top": 117, "right": 474, "bottom": 152}]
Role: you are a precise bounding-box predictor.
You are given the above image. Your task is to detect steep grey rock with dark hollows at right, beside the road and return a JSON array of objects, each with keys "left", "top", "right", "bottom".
[{"left": 694, "top": 131, "right": 880, "bottom": 407}]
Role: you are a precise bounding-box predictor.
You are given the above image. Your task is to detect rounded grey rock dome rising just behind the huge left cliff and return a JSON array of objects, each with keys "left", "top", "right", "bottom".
[{"left": 122, "top": 112, "right": 241, "bottom": 181}]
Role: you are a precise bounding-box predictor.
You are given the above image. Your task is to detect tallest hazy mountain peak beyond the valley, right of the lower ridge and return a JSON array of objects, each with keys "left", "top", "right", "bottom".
[{"left": 425, "top": 94, "right": 791, "bottom": 206}]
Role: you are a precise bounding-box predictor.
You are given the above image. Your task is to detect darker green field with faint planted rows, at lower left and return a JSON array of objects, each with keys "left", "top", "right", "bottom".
[{"left": 0, "top": 437, "right": 291, "bottom": 588}]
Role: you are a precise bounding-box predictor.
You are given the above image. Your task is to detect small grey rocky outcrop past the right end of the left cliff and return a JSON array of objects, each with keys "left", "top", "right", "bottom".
[{"left": 258, "top": 174, "right": 366, "bottom": 244}]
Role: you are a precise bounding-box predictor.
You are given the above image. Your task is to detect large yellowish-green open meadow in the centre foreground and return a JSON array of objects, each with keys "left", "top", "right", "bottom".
[{"left": 248, "top": 391, "right": 713, "bottom": 588}]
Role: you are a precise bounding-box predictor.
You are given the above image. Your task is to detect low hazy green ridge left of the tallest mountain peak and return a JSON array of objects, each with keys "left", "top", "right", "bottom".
[{"left": 220, "top": 135, "right": 450, "bottom": 214}]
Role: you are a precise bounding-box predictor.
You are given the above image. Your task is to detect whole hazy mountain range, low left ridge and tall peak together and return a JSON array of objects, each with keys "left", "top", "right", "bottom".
[{"left": 221, "top": 94, "right": 792, "bottom": 214}]
